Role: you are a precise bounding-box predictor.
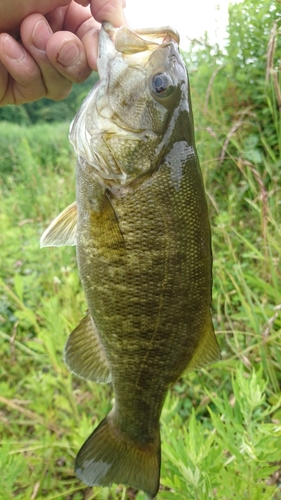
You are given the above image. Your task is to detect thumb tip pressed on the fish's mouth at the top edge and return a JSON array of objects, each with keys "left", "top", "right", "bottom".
[{"left": 91, "top": 0, "right": 126, "bottom": 27}]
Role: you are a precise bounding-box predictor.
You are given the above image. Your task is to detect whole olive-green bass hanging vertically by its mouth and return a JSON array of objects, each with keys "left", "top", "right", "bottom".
[{"left": 41, "top": 22, "right": 220, "bottom": 498}]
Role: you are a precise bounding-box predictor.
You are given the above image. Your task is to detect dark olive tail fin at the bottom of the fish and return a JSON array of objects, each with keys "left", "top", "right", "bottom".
[{"left": 75, "top": 416, "right": 161, "bottom": 498}]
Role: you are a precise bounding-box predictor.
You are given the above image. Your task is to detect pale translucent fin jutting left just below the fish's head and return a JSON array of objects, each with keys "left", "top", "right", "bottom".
[{"left": 40, "top": 201, "right": 77, "bottom": 248}]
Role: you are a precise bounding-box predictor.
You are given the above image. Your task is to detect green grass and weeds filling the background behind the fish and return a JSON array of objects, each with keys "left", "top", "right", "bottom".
[{"left": 0, "top": 0, "right": 281, "bottom": 500}]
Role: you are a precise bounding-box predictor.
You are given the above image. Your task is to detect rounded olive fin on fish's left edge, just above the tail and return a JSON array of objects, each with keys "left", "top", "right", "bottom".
[{"left": 64, "top": 313, "right": 111, "bottom": 383}]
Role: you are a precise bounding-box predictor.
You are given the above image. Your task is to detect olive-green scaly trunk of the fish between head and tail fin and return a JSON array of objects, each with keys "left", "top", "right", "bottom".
[{"left": 77, "top": 146, "right": 211, "bottom": 440}]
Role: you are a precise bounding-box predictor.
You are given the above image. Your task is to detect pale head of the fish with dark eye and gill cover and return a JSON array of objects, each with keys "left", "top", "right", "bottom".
[{"left": 70, "top": 23, "right": 189, "bottom": 194}]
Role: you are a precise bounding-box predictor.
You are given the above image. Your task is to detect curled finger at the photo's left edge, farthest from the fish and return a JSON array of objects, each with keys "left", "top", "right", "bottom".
[{"left": 0, "top": 33, "right": 46, "bottom": 106}]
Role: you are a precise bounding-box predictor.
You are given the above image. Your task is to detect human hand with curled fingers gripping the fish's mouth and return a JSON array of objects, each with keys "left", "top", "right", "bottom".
[{"left": 0, "top": 0, "right": 125, "bottom": 106}]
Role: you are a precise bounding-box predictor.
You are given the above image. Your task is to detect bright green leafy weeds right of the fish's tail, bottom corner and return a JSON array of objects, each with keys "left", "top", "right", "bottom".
[{"left": 160, "top": 365, "right": 281, "bottom": 500}]
